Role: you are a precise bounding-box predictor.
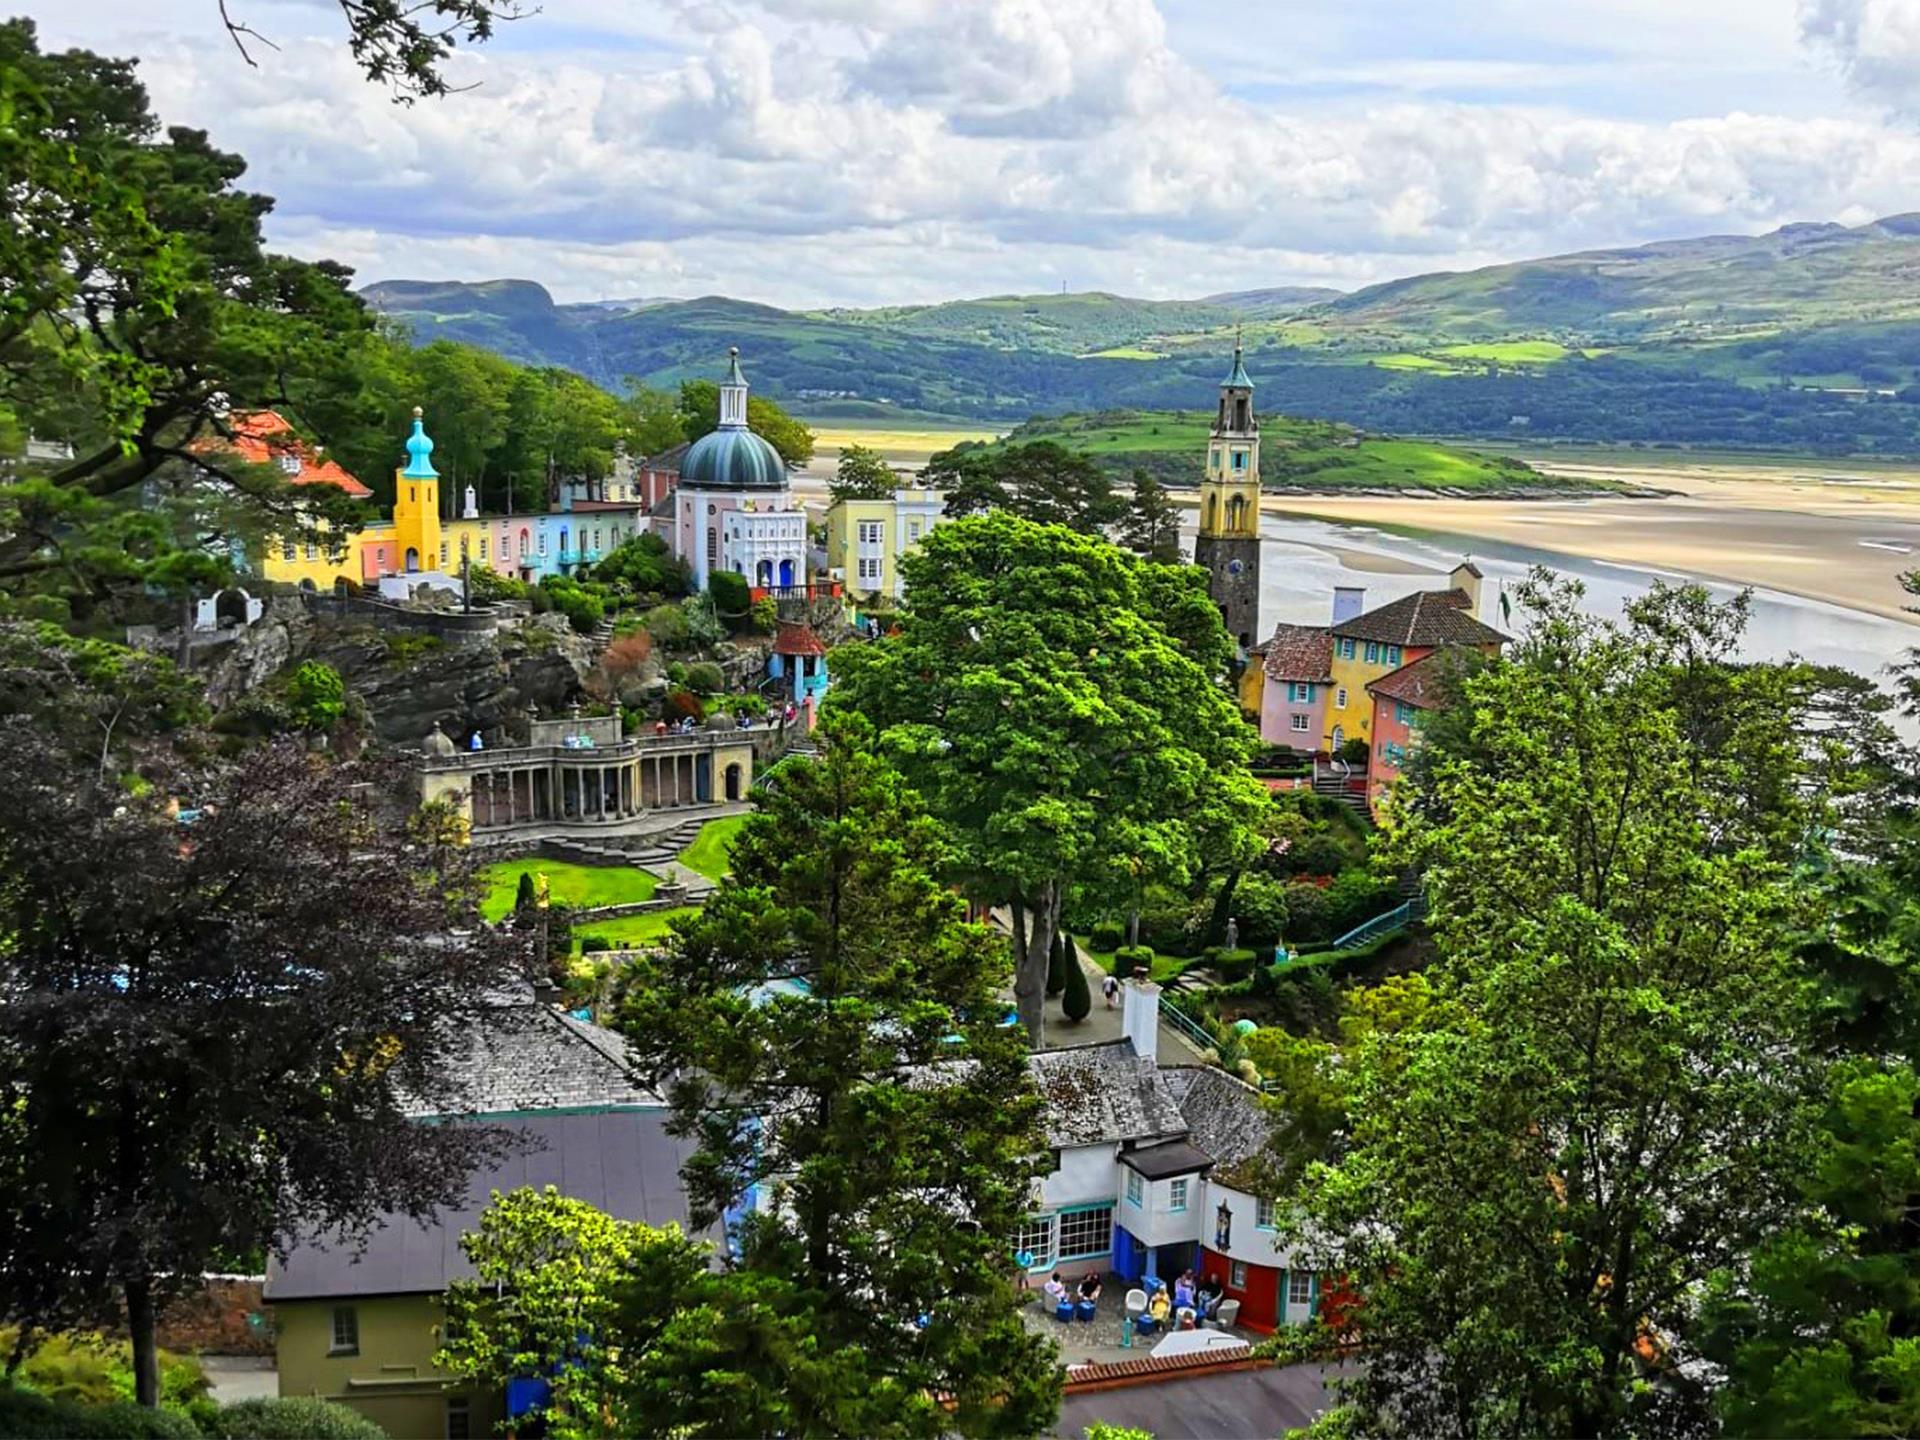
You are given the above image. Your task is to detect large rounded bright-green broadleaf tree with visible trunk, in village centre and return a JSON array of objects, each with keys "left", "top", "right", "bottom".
[{"left": 828, "top": 513, "right": 1269, "bottom": 1044}]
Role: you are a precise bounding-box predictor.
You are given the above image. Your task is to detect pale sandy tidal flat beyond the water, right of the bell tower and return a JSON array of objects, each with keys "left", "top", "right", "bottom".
[{"left": 1265, "top": 459, "right": 1920, "bottom": 624}]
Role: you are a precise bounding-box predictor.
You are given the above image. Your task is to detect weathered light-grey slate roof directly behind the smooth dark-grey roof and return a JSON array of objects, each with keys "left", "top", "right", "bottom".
[{"left": 419, "top": 998, "right": 660, "bottom": 1116}]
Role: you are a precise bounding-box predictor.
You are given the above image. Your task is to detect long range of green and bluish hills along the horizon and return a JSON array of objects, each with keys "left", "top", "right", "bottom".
[{"left": 363, "top": 215, "right": 1920, "bottom": 455}]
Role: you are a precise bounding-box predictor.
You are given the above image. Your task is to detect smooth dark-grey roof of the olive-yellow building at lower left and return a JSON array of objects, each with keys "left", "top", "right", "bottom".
[{"left": 265, "top": 1110, "right": 691, "bottom": 1302}]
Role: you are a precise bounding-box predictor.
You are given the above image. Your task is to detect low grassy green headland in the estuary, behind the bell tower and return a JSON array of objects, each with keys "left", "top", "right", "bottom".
[{"left": 998, "top": 411, "right": 1613, "bottom": 495}]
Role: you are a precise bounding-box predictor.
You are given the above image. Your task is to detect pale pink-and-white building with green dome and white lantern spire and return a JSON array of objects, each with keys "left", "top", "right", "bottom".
[{"left": 672, "top": 348, "right": 806, "bottom": 589}]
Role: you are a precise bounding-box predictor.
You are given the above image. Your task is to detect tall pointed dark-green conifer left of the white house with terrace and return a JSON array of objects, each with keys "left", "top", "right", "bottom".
[{"left": 614, "top": 716, "right": 1060, "bottom": 1436}]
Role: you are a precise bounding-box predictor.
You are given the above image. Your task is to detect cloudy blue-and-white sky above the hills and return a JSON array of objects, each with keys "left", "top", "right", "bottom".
[{"left": 29, "top": 0, "right": 1920, "bottom": 307}]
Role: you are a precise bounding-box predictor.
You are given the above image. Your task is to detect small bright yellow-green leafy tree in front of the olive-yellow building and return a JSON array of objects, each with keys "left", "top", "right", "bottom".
[{"left": 436, "top": 1185, "right": 707, "bottom": 1440}]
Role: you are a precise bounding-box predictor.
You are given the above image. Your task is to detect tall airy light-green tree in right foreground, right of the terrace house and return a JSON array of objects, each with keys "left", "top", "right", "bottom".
[{"left": 1292, "top": 580, "right": 1824, "bottom": 1434}]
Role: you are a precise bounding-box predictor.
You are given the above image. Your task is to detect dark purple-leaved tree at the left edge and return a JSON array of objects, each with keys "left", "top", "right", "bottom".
[{"left": 0, "top": 687, "right": 520, "bottom": 1405}]
